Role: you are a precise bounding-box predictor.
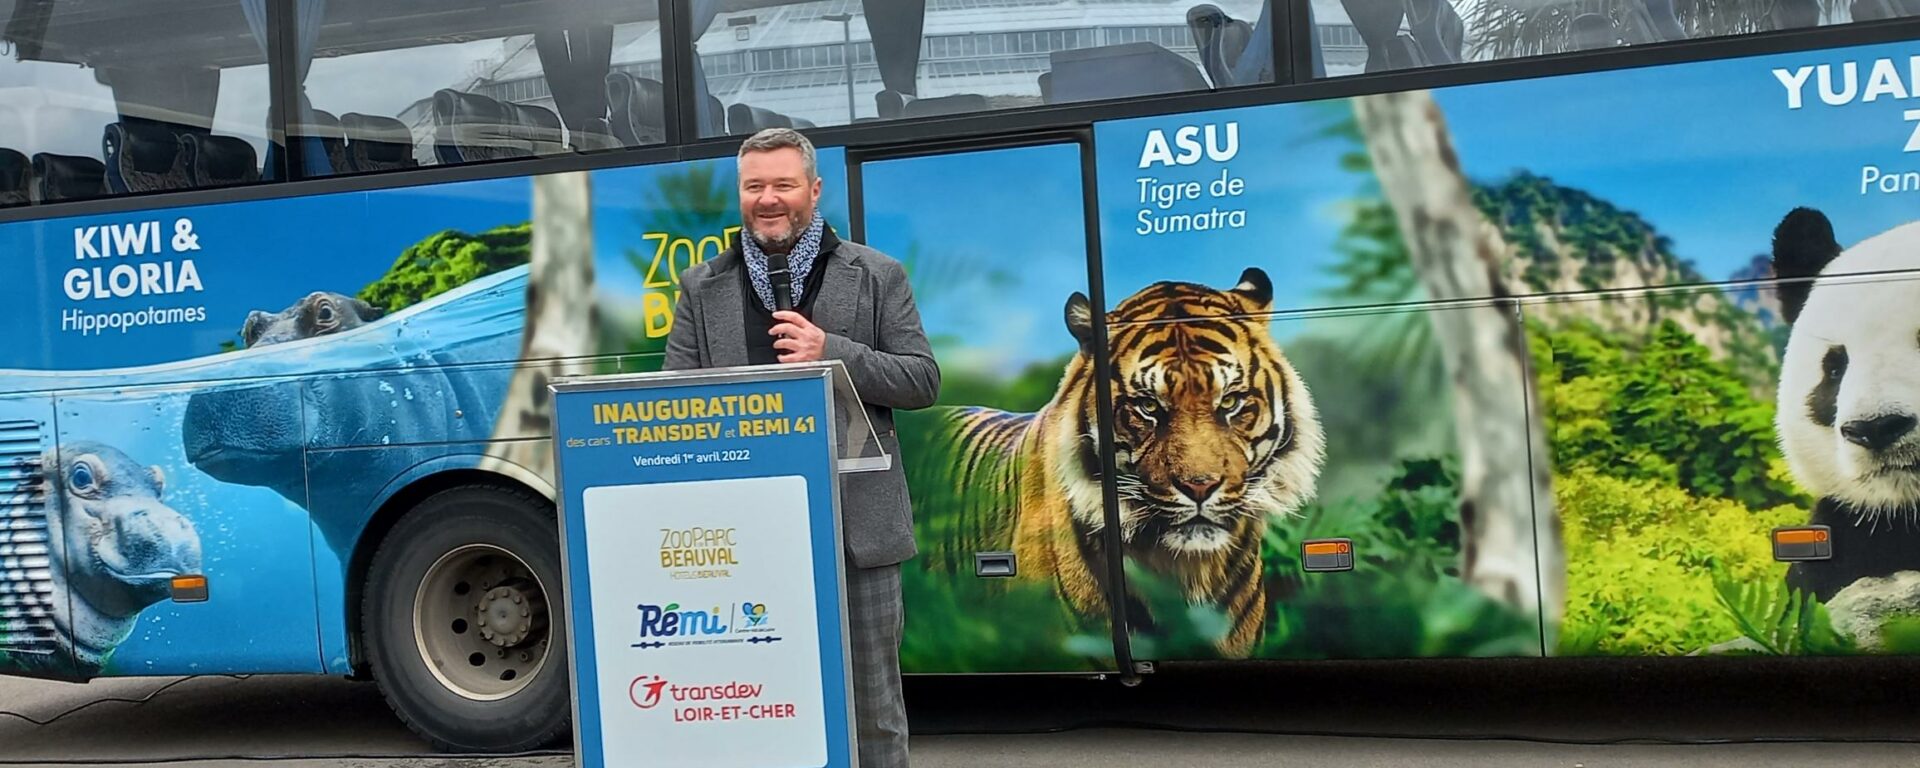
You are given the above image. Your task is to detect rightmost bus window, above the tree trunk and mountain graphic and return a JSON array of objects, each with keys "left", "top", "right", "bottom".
[{"left": 1309, "top": 0, "right": 1920, "bottom": 77}]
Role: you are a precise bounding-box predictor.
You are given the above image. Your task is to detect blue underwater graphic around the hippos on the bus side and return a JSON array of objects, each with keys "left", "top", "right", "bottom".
[{"left": 0, "top": 267, "right": 528, "bottom": 674}]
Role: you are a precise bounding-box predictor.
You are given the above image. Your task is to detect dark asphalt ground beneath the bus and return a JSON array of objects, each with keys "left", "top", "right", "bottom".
[{"left": 0, "top": 659, "right": 1920, "bottom": 768}]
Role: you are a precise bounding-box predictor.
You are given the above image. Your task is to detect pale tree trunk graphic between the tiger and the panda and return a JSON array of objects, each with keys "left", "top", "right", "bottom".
[{"left": 1354, "top": 90, "right": 1565, "bottom": 637}]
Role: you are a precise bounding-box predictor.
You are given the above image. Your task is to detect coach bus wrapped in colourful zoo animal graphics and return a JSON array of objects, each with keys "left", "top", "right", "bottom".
[{"left": 0, "top": 0, "right": 1920, "bottom": 753}]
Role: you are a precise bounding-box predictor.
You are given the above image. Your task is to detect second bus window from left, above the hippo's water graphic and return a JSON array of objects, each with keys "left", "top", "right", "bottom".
[{"left": 288, "top": 0, "right": 666, "bottom": 177}]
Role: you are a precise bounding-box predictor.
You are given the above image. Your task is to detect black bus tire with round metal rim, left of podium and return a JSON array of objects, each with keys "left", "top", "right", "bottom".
[{"left": 361, "top": 484, "right": 572, "bottom": 753}]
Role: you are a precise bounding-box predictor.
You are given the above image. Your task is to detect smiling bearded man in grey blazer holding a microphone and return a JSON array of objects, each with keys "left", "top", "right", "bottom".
[{"left": 664, "top": 129, "right": 941, "bottom": 768}]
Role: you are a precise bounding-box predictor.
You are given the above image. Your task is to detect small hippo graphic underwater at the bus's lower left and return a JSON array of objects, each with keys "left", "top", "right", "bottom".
[{"left": 0, "top": 442, "right": 200, "bottom": 678}]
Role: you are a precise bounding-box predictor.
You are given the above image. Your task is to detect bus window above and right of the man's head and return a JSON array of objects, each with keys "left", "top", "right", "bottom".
[{"left": 689, "top": 0, "right": 1275, "bottom": 136}]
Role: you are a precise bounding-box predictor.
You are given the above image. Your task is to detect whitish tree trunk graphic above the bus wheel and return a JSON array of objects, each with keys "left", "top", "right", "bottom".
[{"left": 482, "top": 173, "right": 599, "bottom": 482}]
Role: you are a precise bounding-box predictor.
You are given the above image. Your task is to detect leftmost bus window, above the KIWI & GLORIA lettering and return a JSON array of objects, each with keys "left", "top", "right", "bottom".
[{"left": 0, "top": 0, "right": 275, "bottom": 205}]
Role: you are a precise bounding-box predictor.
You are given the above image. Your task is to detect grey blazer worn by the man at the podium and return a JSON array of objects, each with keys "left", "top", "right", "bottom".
[{"left": 664, "top": 232, "right": 941, "bottom": 568}]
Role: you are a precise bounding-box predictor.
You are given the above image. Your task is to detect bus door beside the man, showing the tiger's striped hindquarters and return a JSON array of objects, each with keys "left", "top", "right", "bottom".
[{"left": 848, "top": 132, "right": 1131, "bottom": 674}]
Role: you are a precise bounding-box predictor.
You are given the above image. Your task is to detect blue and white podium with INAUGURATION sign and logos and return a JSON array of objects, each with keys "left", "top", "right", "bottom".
[{"left": 549, "top": 361, "right": 893, "bottom": 768}]
